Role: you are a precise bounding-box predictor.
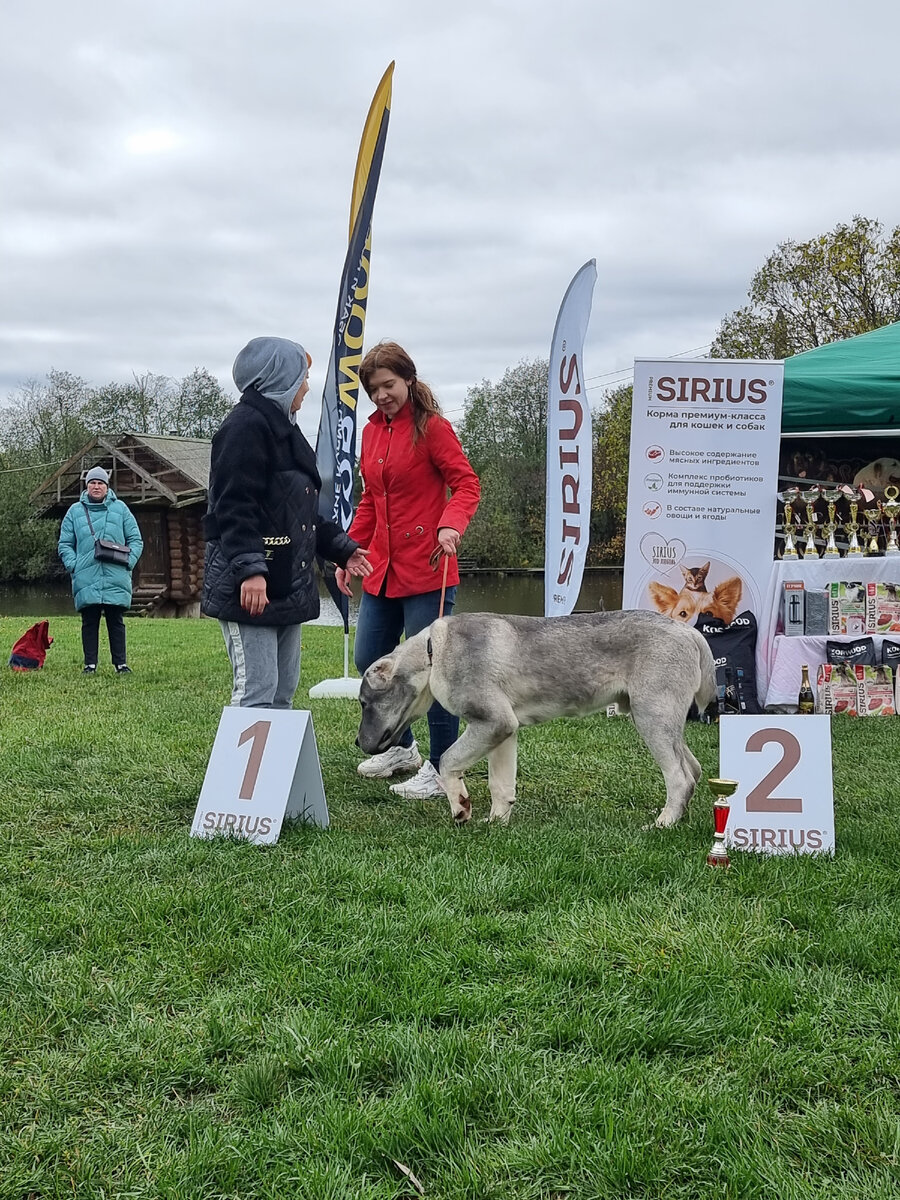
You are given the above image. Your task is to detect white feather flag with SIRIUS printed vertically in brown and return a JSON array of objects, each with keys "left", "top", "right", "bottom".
[{"left": 544, "top": 258, "right": 596, "bottom": 617}]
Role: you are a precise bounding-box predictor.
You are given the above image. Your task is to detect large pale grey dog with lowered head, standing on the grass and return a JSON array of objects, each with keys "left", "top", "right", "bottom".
[{"left": 358, "top": 611, "right": 715, "bottom": 826}]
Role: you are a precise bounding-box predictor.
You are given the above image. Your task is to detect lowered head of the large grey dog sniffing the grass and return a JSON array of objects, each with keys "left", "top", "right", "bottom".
[{"left": 356, "top": 638, "right": 433, "bottom": 754}]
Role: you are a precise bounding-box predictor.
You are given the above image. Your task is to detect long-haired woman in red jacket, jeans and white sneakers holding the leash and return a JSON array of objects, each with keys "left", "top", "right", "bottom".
[{"left": 337, "top": 342, "right": 481, "bottom": 799}]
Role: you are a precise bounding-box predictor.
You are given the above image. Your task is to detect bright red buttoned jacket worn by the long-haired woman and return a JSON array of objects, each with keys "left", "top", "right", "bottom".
[{"left": 349, "top": 403, "right": 481, "bottom": 596}]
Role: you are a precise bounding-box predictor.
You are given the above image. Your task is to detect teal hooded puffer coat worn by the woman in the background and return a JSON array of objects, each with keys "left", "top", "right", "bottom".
[{"left": 59, "top": 487, "right": 144, "bottom": 612}]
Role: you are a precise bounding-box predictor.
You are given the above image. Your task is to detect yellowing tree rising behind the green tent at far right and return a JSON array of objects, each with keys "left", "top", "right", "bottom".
[{"left": 709, "top": 216, "right": 900, "bottom": 359}]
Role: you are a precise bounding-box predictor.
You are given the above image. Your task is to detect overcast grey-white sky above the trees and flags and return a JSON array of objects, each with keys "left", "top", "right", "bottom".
[{"left": 0, "top": 0, "right": 900, "bottom": 439}]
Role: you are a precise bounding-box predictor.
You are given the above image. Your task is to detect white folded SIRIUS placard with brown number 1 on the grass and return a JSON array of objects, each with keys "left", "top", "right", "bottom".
[{"left": 191, "top": 707, "right": 328, "bottom": 844}]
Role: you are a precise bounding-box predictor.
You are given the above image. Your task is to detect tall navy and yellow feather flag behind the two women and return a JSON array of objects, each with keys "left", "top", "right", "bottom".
[{"left": 316, "top": 62, "right": 394, "bottom": 552}]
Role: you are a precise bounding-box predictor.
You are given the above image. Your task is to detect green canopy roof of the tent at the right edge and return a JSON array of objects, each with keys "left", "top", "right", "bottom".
[{"left": 781, "top": 322, "right": 900, "bottom": 434}]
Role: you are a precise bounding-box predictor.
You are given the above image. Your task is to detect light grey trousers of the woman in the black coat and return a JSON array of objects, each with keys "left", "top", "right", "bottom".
[{"left": 218, "top": 620, "right": 300, "bottom": 708}]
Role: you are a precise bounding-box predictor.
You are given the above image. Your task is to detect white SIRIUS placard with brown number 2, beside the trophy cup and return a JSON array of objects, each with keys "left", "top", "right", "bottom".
[{"left": 719, "top": 713, "right": 834, "bottom": 854}]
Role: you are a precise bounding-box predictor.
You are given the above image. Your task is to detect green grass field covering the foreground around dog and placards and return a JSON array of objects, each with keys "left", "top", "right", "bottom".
[{"left": 0, "top": 617, "right": 900, "bottom": 1200}]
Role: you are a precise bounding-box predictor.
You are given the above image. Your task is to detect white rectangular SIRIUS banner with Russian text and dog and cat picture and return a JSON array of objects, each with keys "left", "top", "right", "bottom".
[{"left": 622, "top": 359, "right": 784, "bottom": 628}]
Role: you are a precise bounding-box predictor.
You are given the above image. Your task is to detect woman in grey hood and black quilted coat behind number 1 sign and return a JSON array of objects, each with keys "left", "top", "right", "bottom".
[{"left": 202, "top": 337, "right": 371, "bottom": 708}]
